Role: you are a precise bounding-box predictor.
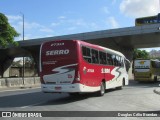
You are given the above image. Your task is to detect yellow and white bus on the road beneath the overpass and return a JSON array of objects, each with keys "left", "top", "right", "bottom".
[{"left": 134, "top": 59, "right": 160, "bottom": 82}]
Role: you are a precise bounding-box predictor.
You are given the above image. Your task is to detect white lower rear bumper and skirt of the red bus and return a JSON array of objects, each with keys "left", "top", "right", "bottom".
[{"left": 41, "top": 83, "right": 100, "bottom": 93}]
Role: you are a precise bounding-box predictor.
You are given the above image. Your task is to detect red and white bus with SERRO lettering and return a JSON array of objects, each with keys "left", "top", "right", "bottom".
[{"left": 40, "top": 40, "right": 128, "bottom": 96}]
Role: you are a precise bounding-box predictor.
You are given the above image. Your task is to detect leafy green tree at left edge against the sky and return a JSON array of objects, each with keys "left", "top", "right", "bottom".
[{"left": 0, "top": 13, "right": 19, "bottom": 48}]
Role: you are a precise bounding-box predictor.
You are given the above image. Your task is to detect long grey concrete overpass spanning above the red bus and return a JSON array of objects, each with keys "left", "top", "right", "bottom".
[{"left": 0, "top": 24, "right": 160, "bottom": 76}]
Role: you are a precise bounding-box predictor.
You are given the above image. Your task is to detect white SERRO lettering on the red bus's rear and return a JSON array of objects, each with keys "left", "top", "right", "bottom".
[{"left": 46, "top": 49, "right": 69, "bottom": 56}]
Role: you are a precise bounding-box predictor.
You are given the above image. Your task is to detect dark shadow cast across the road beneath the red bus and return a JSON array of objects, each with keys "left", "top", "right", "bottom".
[{"left": 0, "top": 80, "right": 160, "bottom": 109}]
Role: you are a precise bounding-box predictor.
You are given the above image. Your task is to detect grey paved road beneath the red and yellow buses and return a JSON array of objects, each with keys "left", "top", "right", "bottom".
[{"left": 0, "top": 80, "right": 160, "bottom": 119}]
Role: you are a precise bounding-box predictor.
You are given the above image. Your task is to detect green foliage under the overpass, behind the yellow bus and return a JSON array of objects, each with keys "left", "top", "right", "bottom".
[{"left": 133, "top": 49, "right": 149, "bottom": 60}]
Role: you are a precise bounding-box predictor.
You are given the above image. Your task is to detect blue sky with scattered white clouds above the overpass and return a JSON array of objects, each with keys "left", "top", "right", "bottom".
[{"left": 0, "top": 0, "right": 160, "bottom": 51}]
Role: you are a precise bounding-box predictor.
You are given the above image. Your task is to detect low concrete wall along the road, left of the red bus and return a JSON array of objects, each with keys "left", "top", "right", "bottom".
[{"left": 0, "top": 77, "right": 40, "bottom": 88}]
